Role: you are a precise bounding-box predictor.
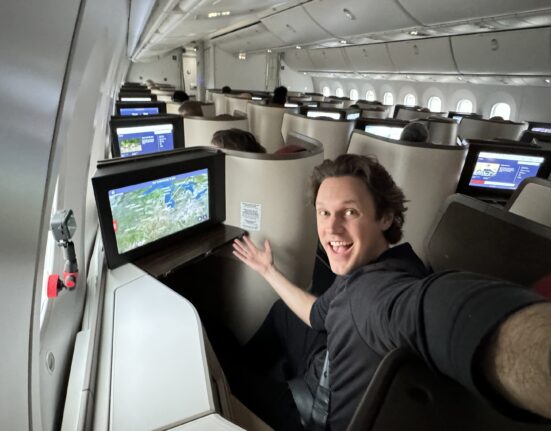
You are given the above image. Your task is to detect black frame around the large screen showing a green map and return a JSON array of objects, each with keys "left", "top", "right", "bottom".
[{"left": 92, "top": 148, "right": 226, "bottom": 269}]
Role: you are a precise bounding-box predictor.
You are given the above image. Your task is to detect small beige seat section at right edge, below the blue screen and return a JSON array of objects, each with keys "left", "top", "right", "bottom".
[{"left": 505, "top": 177, "right": 551, "bottom": 228}]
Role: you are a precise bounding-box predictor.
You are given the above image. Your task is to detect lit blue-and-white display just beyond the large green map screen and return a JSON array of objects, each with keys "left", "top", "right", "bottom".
[{"left": 117, "top": 124, "right": 174, "bottom": 157}]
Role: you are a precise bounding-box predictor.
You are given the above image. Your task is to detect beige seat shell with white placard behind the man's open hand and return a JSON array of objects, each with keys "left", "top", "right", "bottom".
[{"left": 223, "top": 147, "right": 323, "bottom": 341}]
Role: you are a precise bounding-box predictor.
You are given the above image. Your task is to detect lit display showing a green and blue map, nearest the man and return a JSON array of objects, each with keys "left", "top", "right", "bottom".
[{"left": 109, "top": 169, "right": 209, "bottom": 254}]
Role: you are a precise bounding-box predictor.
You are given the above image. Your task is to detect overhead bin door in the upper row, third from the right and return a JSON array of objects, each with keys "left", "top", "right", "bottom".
[{"left": 262, "top": 6, "right": 332, "bottom": 44}]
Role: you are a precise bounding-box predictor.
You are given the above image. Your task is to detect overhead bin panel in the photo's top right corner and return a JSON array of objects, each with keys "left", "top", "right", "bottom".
[{"left": 400, "top": 0, "right": 550, "bottom": 25}]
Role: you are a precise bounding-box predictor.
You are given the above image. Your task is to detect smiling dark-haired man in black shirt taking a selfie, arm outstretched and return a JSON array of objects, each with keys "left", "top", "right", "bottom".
[{"left": 226, "top": 155, "right": 551, "bottom": 430}]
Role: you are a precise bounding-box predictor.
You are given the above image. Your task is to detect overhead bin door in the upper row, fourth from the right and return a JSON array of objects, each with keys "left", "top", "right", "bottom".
[{"left": 212, "top": 23, "right": 283, "bottom": 53}]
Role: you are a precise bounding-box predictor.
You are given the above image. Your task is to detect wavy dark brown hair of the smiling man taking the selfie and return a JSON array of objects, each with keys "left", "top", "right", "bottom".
[{"left": 310, "top": 154, "right": 407, "bottom": 244}]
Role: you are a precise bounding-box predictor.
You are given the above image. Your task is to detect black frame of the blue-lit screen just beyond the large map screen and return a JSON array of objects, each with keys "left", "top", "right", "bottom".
[{"left": 109, "top": 114, "right": 185, "bottom": 159}]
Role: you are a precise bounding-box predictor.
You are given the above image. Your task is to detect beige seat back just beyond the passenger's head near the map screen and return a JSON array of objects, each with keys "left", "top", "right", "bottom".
[{"left": 184, "top": 117, "right": 248, "bottom": 148}]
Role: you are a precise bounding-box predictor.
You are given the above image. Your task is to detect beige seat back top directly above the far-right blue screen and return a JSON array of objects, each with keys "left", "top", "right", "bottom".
[{"left": 457, "top": 117, "right": 528, "bottom": 140}]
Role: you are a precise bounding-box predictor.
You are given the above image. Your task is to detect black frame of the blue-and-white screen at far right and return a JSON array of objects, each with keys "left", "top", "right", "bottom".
[{"left": 456, "top": 140, "right": 551, "bottom": 200}]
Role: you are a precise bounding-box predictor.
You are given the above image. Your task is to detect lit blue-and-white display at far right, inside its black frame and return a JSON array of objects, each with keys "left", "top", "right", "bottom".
[{"left": 469, "top": 152, "right": 544, "bottom": 190}]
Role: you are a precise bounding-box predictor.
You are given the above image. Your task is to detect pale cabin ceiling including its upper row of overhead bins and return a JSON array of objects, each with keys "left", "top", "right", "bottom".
[{"left": 132, "top": 0, "right": 551, "bottom": 70}]
